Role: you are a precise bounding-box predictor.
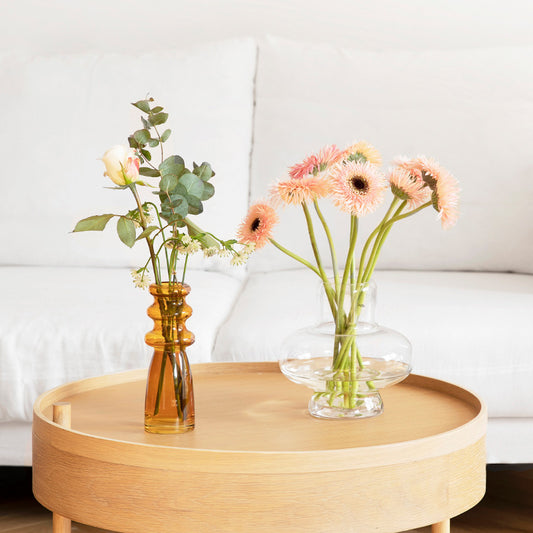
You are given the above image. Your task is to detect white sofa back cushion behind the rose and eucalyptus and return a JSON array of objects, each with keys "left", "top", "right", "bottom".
[{"left": 0, "top": 39, "right": 256, "bottom": 272}]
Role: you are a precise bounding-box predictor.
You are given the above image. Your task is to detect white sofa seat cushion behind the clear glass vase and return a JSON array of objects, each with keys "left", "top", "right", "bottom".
[{"left": 213, "top": 270, "right": 533, "bottom": 417}]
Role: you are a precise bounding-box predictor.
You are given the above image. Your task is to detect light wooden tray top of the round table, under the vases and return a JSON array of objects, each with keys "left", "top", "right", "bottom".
[{"left": 31, "top": 363, "right": 486, "bottom": 474}]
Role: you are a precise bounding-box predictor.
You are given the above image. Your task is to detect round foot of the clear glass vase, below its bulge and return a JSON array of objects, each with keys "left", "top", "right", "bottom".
[{"left": 308, "top": 392, "right": 383, "bottom": 420}]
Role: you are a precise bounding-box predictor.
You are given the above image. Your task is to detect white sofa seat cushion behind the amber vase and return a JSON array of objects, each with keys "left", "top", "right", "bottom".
[{"left": 0, "top": 267, "right": 241, "bottom": 421}]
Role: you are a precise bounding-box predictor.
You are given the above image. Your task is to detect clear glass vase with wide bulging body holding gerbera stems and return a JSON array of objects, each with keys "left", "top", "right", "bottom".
[{"left": 280, "top": 281, "right": 411, "bottom": 419}]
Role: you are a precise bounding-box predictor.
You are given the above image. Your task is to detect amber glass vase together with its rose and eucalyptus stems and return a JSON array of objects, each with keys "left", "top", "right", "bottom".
[{"left": 74, "top": 98, "right": 254, "bottom": 433}]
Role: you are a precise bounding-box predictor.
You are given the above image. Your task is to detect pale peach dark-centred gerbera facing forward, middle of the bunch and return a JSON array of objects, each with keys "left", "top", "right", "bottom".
[{"left": 331, "top": 161, "right": 387, "bottom": 217}]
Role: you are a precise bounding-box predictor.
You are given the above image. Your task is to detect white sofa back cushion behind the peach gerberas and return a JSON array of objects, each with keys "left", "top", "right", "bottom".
[{"left": 250, "top": 38, "right": 533, "bottom": 273}]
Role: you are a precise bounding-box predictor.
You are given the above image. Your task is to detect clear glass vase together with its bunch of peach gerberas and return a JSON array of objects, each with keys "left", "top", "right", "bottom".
[{"left": 239, "top": 142, "right": 459, "bottom": 417}]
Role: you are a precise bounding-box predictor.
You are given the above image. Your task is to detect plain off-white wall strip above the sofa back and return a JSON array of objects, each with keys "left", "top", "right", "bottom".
[{"left": 0, "top": 0, "right": 533, "bottom": 54}]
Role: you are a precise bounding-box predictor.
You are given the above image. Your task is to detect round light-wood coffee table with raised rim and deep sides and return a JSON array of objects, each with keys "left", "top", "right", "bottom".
[{"left": 33, "top": 363, "right": 486, "bottom": 533}]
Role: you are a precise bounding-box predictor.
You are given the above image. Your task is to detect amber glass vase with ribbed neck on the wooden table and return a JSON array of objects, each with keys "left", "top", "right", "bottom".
[{"left": 144, "top": 283, "right": 194, "bottom": 434}]
